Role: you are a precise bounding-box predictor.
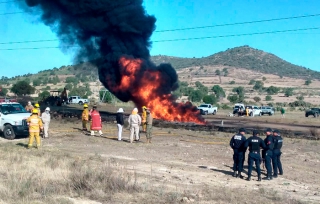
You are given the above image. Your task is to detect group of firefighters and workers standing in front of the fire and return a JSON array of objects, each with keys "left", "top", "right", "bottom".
[{"left": 82, "top": 104, "right": 153, "bottom": 143}]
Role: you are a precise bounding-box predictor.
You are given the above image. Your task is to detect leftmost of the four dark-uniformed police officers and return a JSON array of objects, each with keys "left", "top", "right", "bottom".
[{"left": 230, "top": 128, "right": 246, "bottom": 178}]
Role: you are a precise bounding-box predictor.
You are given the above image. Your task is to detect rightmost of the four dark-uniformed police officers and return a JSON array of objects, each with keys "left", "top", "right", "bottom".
[{"left": 272, "top": 130, "right": 283, "bottom": 178}]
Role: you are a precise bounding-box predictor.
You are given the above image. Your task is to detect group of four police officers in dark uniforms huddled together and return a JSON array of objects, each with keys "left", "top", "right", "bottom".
[{"left": 230, "top": 128, "right": 283, "bottom": 181}]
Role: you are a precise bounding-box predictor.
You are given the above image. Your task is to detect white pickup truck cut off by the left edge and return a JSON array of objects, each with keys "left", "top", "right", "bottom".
[{"left": 0, "top": 102, "right": 30, "bottom": 140}]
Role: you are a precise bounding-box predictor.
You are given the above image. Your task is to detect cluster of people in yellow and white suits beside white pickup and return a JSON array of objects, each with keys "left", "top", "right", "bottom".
[{"left": 25, "top": 101, "right": 51, "bottom": 148}]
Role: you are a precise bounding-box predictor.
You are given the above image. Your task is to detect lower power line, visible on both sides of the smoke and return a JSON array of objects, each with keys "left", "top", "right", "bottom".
[{"left": 0, "top": 27, "right": 320, "bottom": 50}]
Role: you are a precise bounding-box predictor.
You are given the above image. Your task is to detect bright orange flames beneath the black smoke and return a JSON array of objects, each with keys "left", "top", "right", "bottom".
[{"left": 110, "top": 57, "right": 205, "bottom": 124}]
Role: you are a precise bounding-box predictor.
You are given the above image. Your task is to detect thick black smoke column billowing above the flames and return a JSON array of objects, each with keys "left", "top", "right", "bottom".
[{"left": 21, "top": 0, "right": 178, "bottom": 102}]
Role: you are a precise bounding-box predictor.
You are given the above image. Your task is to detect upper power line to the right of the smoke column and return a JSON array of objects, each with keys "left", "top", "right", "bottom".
[{"left": 154, "top": 14, "right": 320, "bottom": 33}]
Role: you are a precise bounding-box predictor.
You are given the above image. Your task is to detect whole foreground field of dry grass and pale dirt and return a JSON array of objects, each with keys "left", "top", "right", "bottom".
[{"left": 0, "top": 107, "right": 320, "bottom": 204}]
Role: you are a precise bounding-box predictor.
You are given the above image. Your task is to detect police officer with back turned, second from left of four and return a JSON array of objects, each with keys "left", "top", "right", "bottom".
[{"left": 244, "top": 130, "right": 266, "bottom": 181}]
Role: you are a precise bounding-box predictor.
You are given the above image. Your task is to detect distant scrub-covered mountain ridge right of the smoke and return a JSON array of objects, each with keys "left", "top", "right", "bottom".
[{"left": 151, "top": 46, "right": 320, "bottom": 79}]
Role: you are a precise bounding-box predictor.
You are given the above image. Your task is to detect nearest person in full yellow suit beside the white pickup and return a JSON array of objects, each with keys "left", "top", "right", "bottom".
[{"left": 27, "top": 108, "right": 43, "bottom": 149}]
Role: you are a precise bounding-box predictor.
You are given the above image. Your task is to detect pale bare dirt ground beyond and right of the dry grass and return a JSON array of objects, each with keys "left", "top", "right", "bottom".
[{"left": 0, "top": 112, "right": 320, "bottom": 204}]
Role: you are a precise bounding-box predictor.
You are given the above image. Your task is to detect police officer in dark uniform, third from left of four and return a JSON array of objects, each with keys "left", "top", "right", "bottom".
[{"left": 264, "top": 128, "right": 274, "bottom": 180}]
